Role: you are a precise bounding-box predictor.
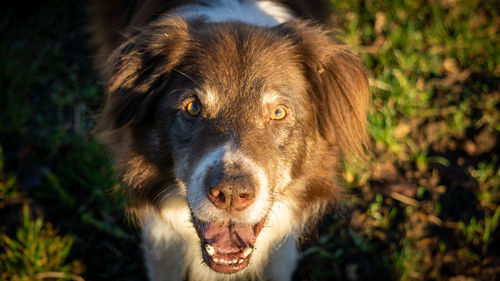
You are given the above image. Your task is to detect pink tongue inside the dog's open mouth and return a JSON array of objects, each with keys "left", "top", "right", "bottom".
[{"left": 203, "top": 222, "right": 257, "bottom": 254}]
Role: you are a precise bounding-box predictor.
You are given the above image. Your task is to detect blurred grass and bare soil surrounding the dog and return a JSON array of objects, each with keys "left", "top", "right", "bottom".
[{"left": 0, "top": 0, "right": 500, "bottom": 281}]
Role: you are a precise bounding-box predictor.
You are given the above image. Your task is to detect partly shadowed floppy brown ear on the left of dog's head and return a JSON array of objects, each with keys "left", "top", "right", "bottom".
[{"left": 98, "top": 18, "right": 189, "bottom": 131}]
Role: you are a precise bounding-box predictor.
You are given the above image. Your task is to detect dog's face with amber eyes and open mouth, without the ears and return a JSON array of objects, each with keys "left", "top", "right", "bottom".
[{"left": 155, "top": 26, "right": 312, "bottom": 273}]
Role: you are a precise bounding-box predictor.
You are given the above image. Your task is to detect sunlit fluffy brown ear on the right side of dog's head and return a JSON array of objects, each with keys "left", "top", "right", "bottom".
[{"left": 279, "top": 21, "right": 370, "bottom": 159}]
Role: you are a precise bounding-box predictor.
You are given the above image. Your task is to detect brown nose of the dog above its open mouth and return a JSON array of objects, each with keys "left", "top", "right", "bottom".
[{"left": 208, "top": 176, "right": 255, "bottom": 212}]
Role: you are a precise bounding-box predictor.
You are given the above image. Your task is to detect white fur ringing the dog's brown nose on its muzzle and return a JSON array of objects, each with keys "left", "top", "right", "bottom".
[{"left": 186, "top": 143, "right": 271, "bottom": 223}]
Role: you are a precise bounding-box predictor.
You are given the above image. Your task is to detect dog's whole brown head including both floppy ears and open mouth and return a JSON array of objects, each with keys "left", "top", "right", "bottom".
[{"left": 100, "top": 18, "right": 369, "bottom": 273}]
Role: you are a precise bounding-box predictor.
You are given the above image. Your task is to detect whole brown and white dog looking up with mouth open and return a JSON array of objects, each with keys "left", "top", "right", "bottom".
[{"left": 94, "top": 0, "right": 369, "bottom": 280}]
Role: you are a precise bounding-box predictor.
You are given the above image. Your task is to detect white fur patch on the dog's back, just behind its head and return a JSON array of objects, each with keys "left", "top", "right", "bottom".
[{"left": 174, "top": 0, "right": 294, "bottom": 26}]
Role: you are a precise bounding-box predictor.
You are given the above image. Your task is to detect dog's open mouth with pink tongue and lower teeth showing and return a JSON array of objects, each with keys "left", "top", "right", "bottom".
[{"left": 193, "top": 213, "right": 265, "bottom": 274}]
